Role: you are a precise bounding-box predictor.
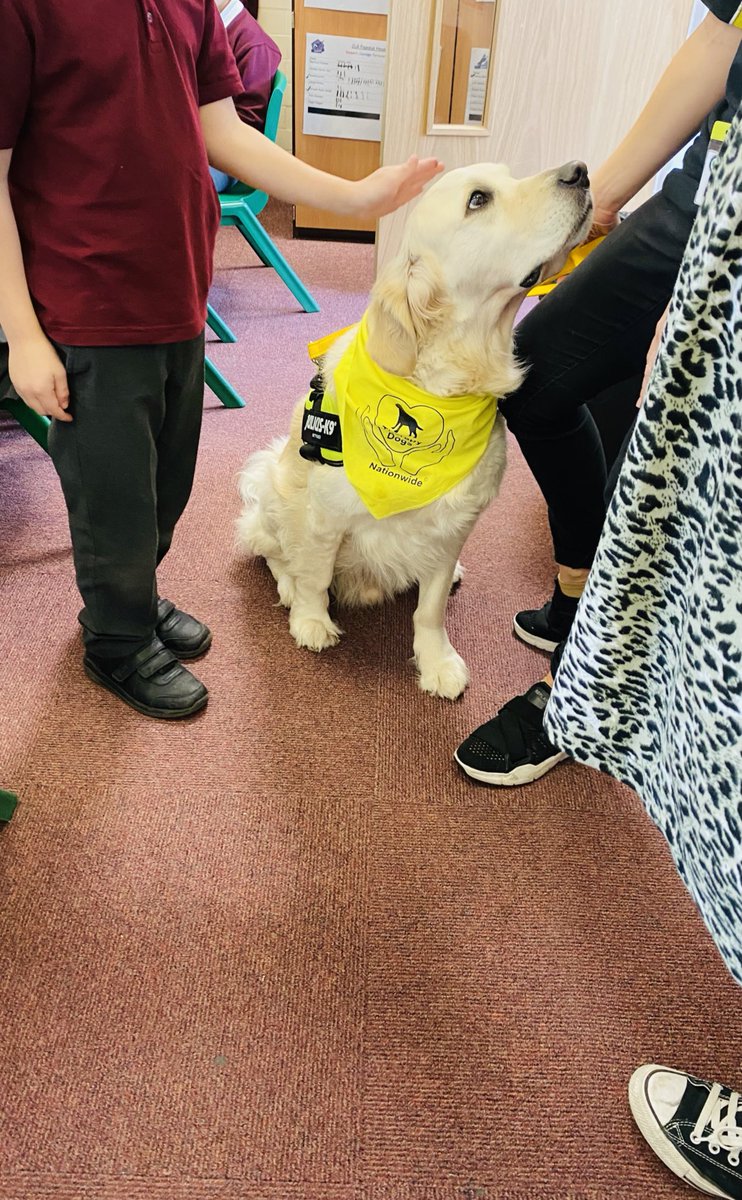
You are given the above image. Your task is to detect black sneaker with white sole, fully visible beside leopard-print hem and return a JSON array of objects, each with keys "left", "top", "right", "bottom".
[{"left": 454, "top": 683, "right": 567, "bottom": 787}]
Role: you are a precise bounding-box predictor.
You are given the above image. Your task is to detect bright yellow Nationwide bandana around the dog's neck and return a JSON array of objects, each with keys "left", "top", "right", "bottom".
[{"left": 305, "top": 317, "right": 497, "bottom": 517}]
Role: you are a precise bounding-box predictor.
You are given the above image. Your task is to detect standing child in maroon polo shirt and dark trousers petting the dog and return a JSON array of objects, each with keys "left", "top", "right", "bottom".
[{"left": 0, "top": 0, "right": 441, "bottom": 718}]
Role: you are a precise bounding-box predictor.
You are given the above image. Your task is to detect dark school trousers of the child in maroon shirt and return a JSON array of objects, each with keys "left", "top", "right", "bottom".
[{"left": 0, "top": 334, "right": 204, "bottom": 658}]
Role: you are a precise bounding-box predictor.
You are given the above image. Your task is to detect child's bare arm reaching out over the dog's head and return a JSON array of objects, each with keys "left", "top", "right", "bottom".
[{"left": 199, "top": 100, "right": 443, "bottom": 220}]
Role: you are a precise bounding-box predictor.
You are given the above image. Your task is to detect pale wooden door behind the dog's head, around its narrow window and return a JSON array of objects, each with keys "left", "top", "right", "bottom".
[{"left": 378, "top": 0, "right": 693, "bottom": 263}]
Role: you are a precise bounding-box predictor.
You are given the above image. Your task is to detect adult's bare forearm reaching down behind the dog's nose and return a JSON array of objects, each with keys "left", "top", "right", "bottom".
[{"left": 592, "top": 13, "right": 742, "bottom": 228}]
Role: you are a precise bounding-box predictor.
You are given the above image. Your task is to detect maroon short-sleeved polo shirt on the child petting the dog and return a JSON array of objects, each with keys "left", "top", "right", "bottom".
[{"left": 0, "top": 0, "right": 243, "bottom": 346}]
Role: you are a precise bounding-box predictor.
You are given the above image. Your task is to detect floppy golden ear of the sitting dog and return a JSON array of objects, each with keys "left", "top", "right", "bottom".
[{"left": 367, "top": 256, "right": 448, "bottom": 376}]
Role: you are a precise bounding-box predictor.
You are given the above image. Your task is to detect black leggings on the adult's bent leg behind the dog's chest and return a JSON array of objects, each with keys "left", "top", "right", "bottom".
[{"left": 502, "top": 178, "right": 696, "bottom": 568}]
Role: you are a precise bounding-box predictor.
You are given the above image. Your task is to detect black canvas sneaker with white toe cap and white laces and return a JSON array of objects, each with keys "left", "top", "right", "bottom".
[{"left": 629, "top": 1064, "right": 742, "bottom": 1200}]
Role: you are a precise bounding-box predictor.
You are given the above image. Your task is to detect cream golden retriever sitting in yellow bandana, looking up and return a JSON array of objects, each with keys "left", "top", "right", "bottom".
[{"left": 237, "top": 162, "right": 592, "bottom": 700}]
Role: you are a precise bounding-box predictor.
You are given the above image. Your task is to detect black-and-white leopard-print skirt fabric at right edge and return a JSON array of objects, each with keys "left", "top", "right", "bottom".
[{"left": 546, "top": 114, "right": 742, "bottom": 984}]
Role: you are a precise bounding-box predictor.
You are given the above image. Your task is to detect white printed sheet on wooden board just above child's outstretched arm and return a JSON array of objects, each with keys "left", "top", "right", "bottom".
[{"left": 303, "top": 34, "right": 387, "bottom": 142}]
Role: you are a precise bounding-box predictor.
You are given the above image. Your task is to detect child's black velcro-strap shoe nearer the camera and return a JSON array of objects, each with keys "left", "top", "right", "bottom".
[{"left": 83, "top": 637, "right": 209, "bottom": 721}]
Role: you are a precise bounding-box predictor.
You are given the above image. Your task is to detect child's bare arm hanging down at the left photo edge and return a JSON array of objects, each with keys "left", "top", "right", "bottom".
[{"left": 0, "top": 150, "right": 72, "bottom": 421}]
